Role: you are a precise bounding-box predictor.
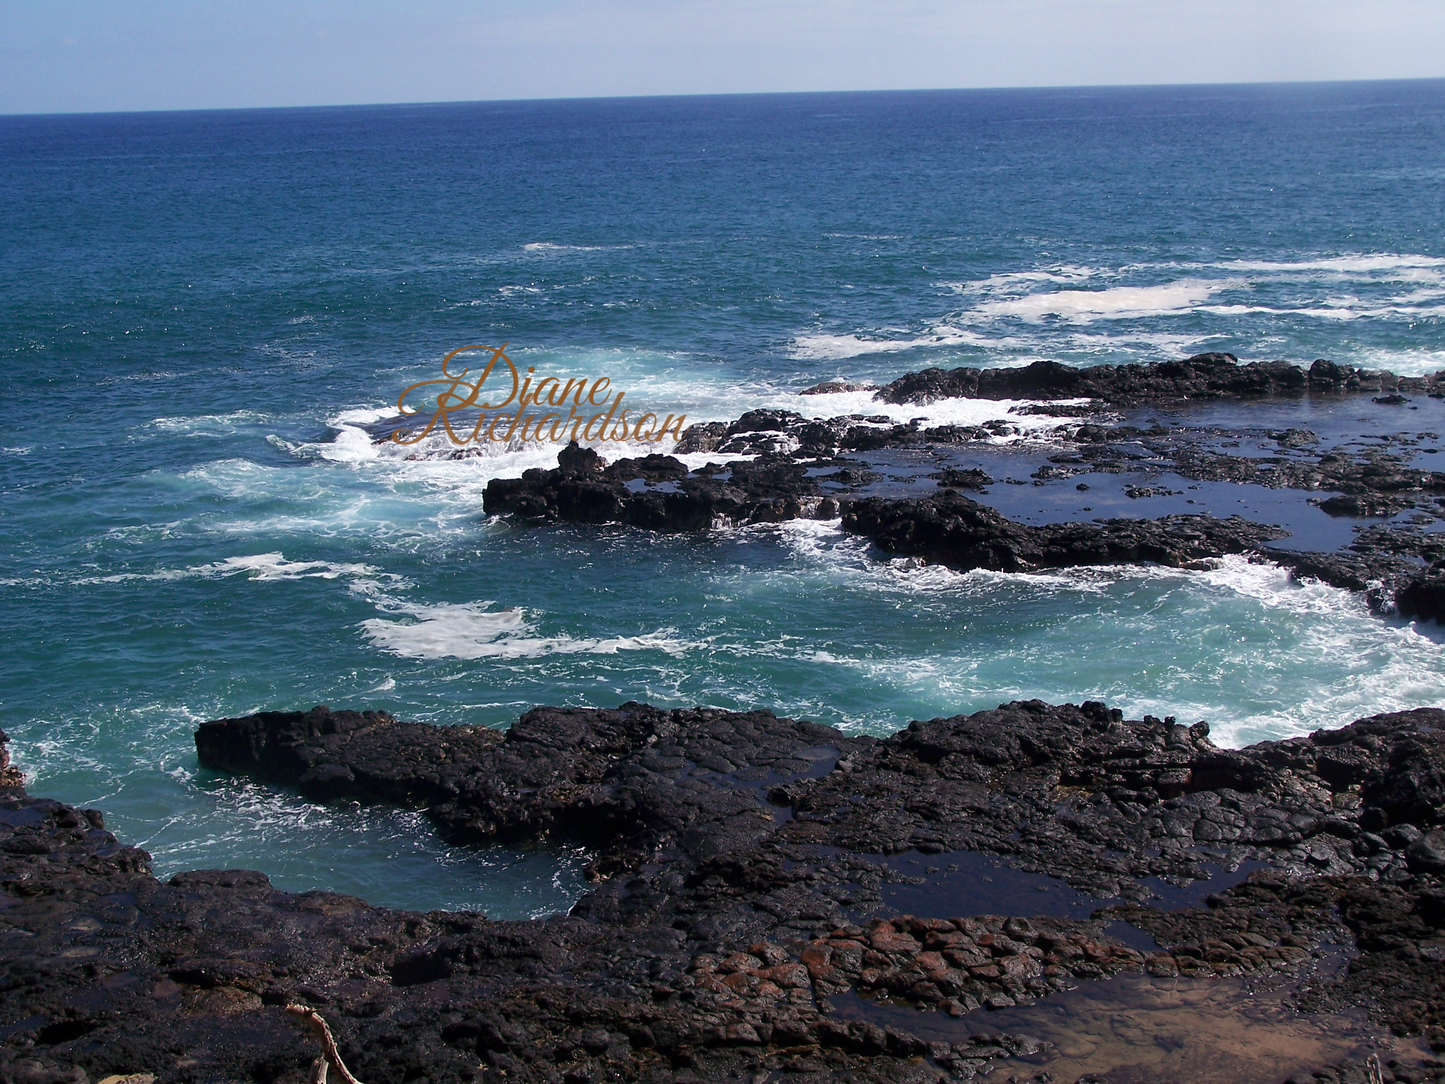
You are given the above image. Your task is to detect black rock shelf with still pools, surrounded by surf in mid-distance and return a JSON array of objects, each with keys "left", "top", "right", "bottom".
[{"left": 484, "top": 354, "right": 1445, "bottom": 620}]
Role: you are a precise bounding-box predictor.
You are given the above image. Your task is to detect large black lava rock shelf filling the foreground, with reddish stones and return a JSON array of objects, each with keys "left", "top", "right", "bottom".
[{"left": 0, "top": 701, "right": 1445, "bottom": 1084}]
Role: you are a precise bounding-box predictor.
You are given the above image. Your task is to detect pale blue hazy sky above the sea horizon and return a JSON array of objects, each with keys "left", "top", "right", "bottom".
[{"left": 0, "top": 0, "right": 1445, "bottom": 113}]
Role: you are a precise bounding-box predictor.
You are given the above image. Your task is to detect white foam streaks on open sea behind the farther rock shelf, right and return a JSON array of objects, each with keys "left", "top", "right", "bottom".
[{"left": 768, "top": 253, "right": 1445, "bottom": 401}]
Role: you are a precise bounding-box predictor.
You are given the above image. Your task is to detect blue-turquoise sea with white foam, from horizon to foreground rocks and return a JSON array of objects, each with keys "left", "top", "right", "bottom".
[{"left": 0, "top": 82, "right": 1445, "bottom": 915}]
